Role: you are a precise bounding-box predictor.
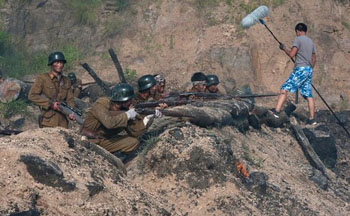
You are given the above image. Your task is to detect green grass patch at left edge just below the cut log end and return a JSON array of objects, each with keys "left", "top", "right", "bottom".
[{"left": 0, "top": 100, "right": 28, "bottom": 119}]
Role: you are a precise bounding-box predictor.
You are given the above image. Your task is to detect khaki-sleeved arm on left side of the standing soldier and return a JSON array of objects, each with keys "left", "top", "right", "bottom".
[{"left": 28, "top": 76, "right": 51, "bottom": 110}]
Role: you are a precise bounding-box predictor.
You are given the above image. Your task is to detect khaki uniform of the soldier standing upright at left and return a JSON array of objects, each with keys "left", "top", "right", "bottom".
[{"left": 28, "top": 73, "right": 74, "bottom": 128}]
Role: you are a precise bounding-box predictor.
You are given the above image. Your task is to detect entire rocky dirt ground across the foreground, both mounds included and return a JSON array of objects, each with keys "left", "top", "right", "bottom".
[{"left": 0, "top": 104, "right": 350, "bottom": 215}]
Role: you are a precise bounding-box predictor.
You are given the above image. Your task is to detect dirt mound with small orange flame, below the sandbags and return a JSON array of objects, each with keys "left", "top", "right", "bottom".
[{"left": 127, "top": 124, "right": 350, "bottom": 215}]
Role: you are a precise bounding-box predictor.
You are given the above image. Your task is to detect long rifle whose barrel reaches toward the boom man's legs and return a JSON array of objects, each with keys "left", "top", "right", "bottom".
[{"left": 166, "top": 92, "right": 280, "bottom": 100}]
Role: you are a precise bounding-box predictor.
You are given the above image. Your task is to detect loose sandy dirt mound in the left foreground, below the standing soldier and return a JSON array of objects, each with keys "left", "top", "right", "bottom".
[{"left": 0, "top": 129, "right": 169, "bottom": 215}]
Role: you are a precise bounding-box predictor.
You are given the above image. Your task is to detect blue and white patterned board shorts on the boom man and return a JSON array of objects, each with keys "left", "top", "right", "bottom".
[{"left": 281, "top": 66, "right": 312, "bottom": 98}]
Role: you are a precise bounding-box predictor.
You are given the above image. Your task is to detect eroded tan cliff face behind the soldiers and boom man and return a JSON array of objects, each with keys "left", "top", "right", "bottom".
[{"left": 1, "top": 0, "right": 350, "bottom": 108}]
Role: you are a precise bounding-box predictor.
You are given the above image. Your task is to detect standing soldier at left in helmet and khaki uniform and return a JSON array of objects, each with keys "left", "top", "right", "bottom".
[{"left": 28, "top": 52, "right": 74, "bottom": 128}]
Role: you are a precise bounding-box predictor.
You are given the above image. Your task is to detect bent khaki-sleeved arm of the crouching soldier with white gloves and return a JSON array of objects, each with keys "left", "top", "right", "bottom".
[{"left": 91, "top": 103, "right": 128, "bottom": 129}]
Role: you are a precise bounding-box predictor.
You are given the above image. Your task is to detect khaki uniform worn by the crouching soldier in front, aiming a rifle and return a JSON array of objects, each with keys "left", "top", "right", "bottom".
[{"left": 82, "top": 97, "right": 146, "bottom": 153}]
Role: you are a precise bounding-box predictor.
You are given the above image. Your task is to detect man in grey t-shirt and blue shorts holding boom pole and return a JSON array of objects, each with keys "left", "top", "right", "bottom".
[{"left": 272, "top": 23, "right": 317, "bottom": 125}]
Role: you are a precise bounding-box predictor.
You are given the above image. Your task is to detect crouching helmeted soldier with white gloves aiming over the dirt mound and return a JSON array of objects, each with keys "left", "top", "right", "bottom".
[{"left": 81, "top": 83, "right": 154, "bottom": 162}]
